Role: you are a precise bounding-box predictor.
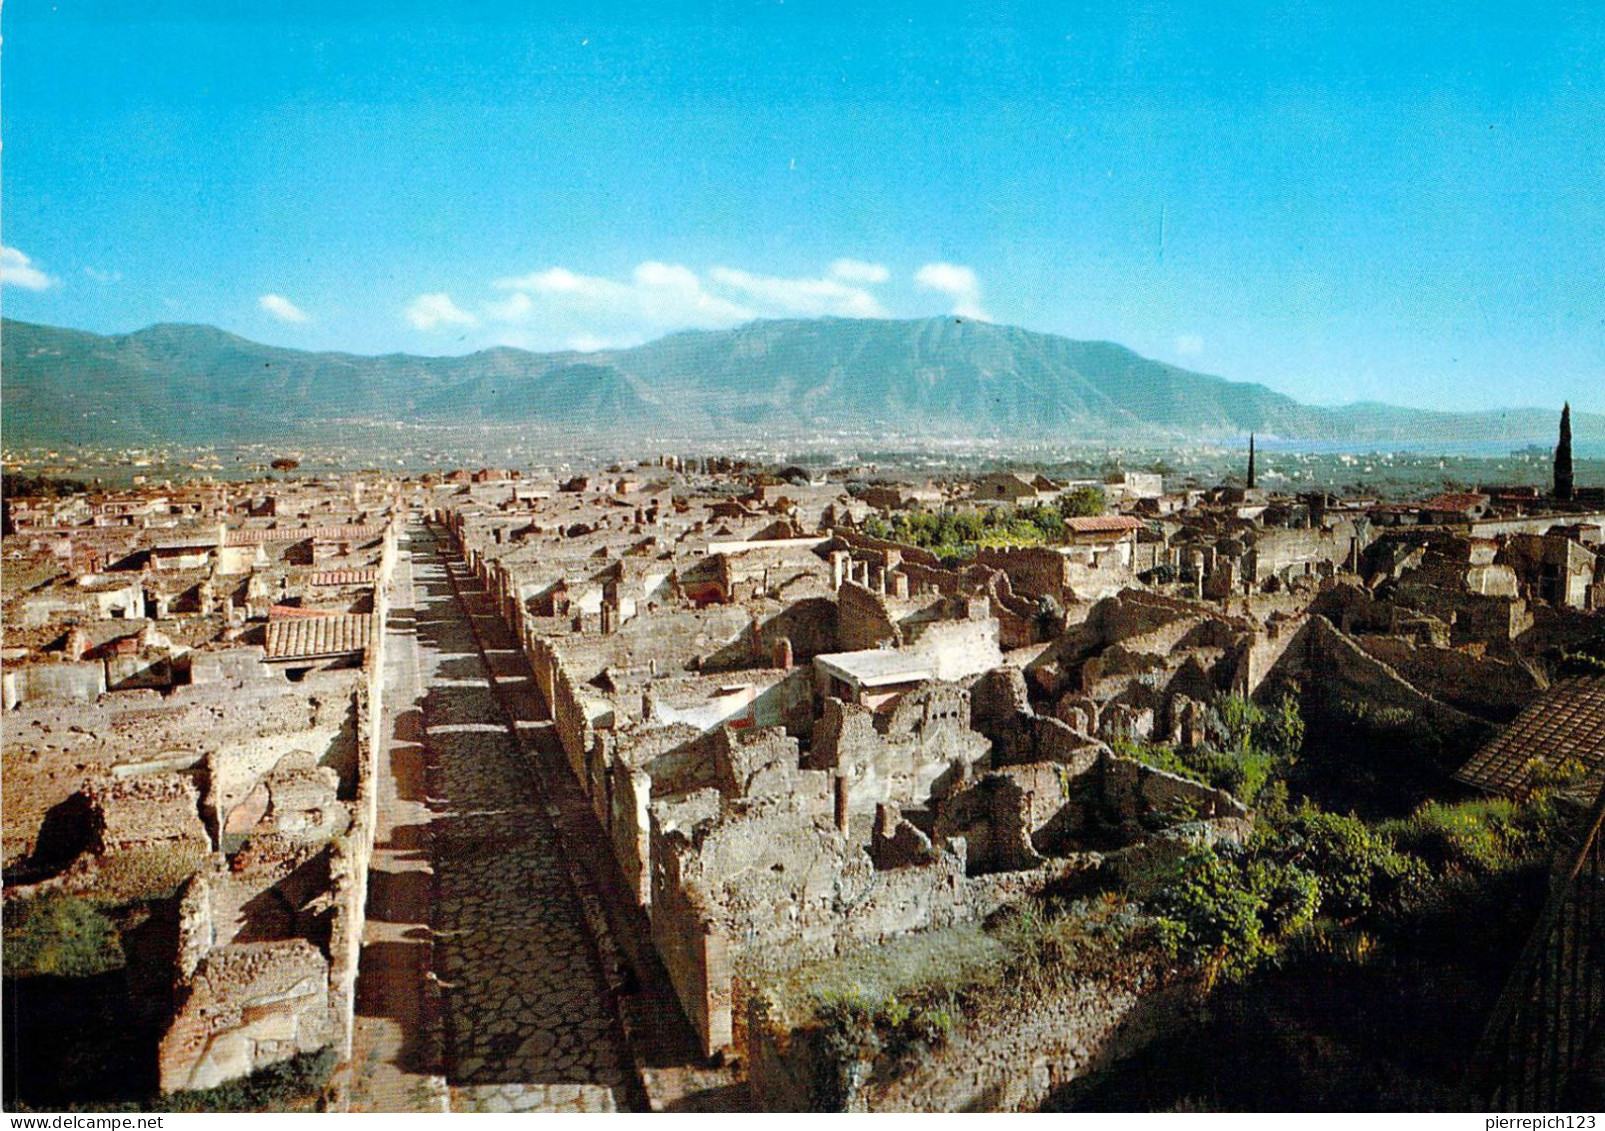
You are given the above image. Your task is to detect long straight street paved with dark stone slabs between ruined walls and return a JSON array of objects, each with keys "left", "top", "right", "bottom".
[{"left": 411, "top": 526, "right": 631, "bottom": 1112}]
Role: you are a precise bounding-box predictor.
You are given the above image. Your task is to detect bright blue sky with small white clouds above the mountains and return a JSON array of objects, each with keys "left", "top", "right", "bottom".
[{"left": 0, "top": 0, "right": 1605, "bottom": 411}]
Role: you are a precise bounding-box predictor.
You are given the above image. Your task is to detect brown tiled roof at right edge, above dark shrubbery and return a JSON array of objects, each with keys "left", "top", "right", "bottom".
[{"left": 1454, "top": 675, "right": 1605, "bottom": 799}]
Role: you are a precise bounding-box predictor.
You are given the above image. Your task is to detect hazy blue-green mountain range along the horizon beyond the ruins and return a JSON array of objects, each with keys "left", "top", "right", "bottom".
[{"left": 0, "top": 318, "right": 1605, "bottom": 446}]
